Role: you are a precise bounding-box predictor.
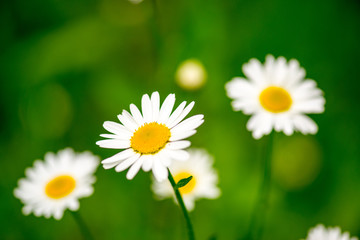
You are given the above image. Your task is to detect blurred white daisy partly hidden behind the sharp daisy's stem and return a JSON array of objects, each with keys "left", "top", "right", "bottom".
[{"left": 152, "top": 149, "right": 220, "bottom": 211}]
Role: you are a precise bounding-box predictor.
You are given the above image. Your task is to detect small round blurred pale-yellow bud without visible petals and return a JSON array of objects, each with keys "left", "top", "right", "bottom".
[{"left": 175, "top": 59, "right": 207, "bottom": 90}]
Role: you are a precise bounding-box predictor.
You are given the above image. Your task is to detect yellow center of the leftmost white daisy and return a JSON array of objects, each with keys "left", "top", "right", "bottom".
[{"left": 45, "top": 175, "right": 76, "bottom": 199}]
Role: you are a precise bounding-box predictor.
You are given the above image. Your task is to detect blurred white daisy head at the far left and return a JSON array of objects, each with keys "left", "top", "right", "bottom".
[{"left": 14, "top": 148, "right": 100, "bottom": 220}]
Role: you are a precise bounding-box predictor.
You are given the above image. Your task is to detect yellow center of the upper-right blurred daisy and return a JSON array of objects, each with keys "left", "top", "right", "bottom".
[{"left": 260, "top": 86, "right": 292, "bottom": 113}]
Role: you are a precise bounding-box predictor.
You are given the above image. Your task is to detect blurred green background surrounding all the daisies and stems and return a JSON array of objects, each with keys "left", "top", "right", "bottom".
[{"left": 0, "top": 0, "right": 360, "bottom": 240}]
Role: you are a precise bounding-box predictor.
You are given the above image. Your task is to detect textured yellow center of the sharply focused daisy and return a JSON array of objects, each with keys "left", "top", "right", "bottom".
[{"left": 130, "top": 122, "right": 171, "bottom": 154}]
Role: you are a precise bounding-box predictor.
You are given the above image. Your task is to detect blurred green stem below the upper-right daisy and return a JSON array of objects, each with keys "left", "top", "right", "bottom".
[{"left": 245, "top": 133, "right": 274, "bottom": 240}]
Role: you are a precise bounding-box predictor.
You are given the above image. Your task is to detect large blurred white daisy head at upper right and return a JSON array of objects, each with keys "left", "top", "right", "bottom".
[{"left": 225, "top": 55, "right": 325, "bottom": 139}]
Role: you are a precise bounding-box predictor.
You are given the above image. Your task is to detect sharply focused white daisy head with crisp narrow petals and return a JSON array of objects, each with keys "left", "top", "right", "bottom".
[{"left": 96, "top": 92, "right": 204, "bottom": 181}]
